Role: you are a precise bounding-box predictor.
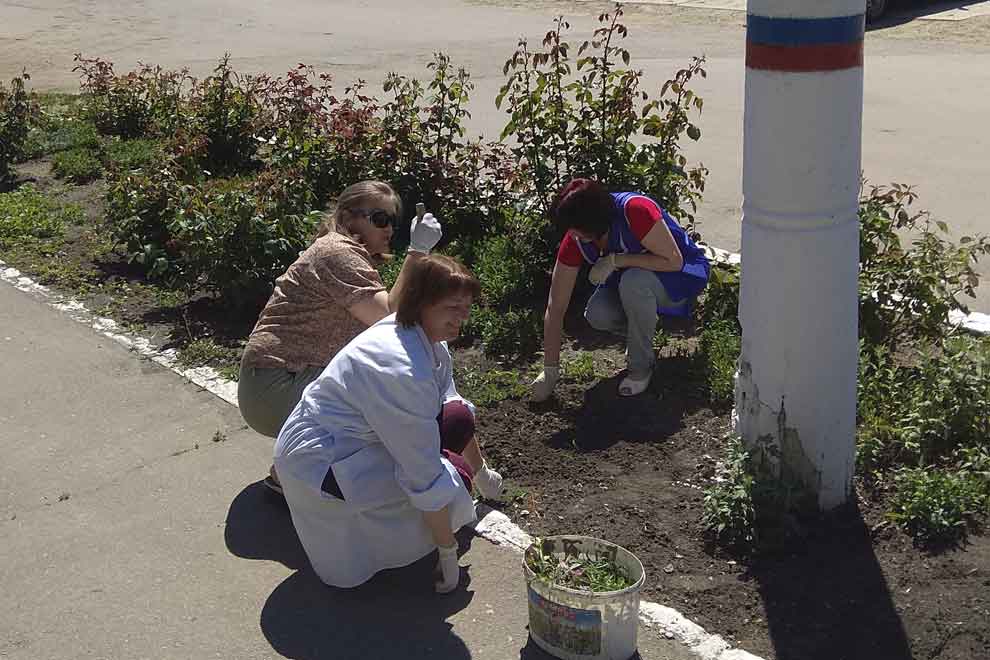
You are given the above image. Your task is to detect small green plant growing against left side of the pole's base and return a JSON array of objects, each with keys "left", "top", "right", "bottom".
[{"left": 701, "top": 437, "right": 757, "bottom": 548}]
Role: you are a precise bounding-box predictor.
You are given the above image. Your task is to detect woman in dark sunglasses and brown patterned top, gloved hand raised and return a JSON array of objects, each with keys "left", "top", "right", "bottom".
[{"left": 237, "top": 181, "right": 501, "bottom": 497}]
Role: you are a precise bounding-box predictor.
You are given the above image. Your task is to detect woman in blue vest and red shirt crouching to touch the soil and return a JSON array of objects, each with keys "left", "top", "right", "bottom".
[{"left": 533, "top": 179, "right": 710, "bottom": 401}]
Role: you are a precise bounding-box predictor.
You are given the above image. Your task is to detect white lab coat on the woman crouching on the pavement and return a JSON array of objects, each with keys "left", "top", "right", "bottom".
[{"left": 274, "top": 315, "right": 475, "bottom": 587}]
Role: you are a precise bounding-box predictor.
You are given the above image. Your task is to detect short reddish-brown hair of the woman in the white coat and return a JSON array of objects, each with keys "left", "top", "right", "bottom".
[{"left": 395, "top": 254, "right": 481, "bottom": 327}]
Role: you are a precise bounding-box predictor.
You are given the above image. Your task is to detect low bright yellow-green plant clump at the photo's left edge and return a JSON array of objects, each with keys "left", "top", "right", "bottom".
[{"left": 0, "top": 184, "right": 82, "bottom": 248}]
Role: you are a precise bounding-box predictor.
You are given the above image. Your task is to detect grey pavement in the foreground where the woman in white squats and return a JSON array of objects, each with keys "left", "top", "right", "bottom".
[{"left": 0, "top": 282, "right": 693, "bottom": 660}]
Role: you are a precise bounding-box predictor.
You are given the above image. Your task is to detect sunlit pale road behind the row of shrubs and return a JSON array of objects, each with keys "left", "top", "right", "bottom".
[{"left": 0, "top": 0, "right": 990, "bottom": 312}]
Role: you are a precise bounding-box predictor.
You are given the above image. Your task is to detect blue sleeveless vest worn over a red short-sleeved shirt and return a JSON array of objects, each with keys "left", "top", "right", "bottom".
[{"left": 578, "top": 192, "right": 711, "bottom": 316}]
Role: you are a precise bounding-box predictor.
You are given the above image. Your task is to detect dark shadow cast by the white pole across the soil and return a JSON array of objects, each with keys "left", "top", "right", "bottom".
[{"left": 742, "top": 504, "right": 912, "bottom": 660}]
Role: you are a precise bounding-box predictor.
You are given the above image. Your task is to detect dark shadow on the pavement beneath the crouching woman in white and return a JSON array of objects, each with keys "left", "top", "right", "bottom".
[{"left": 225, "top": 482, "right": 474, "bottom": 660}]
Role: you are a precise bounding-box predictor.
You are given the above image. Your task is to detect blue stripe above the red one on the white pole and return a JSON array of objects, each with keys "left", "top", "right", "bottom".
[{"left": 746, "top": 14, "right": 866, "bottom": 46}]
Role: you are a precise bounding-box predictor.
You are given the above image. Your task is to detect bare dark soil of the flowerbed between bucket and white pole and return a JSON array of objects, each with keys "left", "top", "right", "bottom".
[{"left": 468, "top": 340, "right": 990, "bottom": 660}]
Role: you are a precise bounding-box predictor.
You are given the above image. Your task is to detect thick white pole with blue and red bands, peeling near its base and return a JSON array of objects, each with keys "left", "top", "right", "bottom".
[{"left": 735, "top": 0, "right": 866, "bottom": 510}]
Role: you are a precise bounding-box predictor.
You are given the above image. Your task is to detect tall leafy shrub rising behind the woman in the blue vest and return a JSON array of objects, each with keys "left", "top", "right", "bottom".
[{"left": 495, "top": 5, "right": 707, "bottom": 226}]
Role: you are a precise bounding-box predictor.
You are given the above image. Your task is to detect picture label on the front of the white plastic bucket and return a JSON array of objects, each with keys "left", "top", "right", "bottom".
[{"left": 528, "top": 587, "right": 602, "bottom": 656}]
